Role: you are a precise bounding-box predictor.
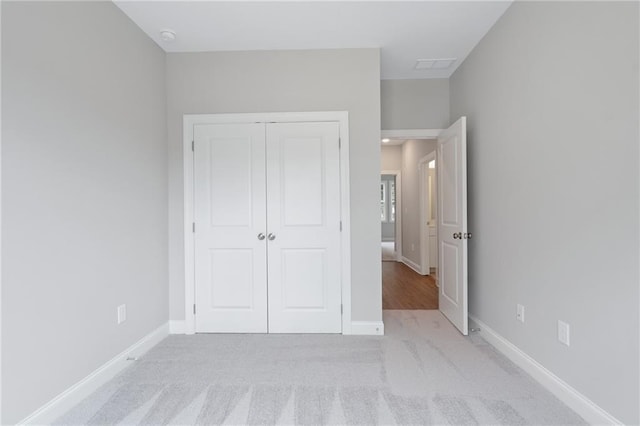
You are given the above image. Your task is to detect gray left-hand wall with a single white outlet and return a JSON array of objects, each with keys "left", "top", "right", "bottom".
[{"left": 1, "top": 2, "right": 168, "bottom": 424}]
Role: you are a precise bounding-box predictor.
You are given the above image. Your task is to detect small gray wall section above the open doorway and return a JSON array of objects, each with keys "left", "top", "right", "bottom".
[{"left": 380, "top": 78, "right": 449, "bottom": 130}]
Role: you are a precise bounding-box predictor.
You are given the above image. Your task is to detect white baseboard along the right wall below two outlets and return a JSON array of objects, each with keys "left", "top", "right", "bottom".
[{"left": 469, "top": 315, "right": 623, "bottom": 425}]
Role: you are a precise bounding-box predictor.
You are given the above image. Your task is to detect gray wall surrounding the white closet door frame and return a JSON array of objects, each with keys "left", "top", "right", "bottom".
[{"left": 167, "top": 49, "right": 382, "bottom": 321}]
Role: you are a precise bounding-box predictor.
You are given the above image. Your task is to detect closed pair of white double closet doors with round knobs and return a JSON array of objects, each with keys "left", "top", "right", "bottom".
[{"left": 194, "top": 122, "right": 342, "bottom": 333}]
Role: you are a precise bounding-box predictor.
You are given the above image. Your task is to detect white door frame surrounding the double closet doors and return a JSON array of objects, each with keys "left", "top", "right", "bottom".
[{"left": 182, "top": 111, "right": 351, "bottom": 334}]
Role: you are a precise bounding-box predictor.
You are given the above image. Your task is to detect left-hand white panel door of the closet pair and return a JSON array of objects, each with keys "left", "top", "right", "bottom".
[{"left": 194, "top": 124, "right": 267, "bottom": 333}]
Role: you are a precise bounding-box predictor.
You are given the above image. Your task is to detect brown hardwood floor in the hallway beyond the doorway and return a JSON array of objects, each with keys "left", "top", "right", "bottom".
[{"left": 382, "top": 262, "right": 438, "bottom": 309}]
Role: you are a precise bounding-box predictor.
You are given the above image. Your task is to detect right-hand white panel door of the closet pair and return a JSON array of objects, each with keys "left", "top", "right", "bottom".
[{"left": 266, "top": 122, "right": 342, "bottom": 333}]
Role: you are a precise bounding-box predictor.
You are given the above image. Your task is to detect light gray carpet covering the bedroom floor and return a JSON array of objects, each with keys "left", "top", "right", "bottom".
[{"left": 56, "top": 311, "right": 586, "bottom": 425}]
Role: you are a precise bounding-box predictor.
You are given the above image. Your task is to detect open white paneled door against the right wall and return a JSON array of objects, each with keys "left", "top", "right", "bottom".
[{"left": 437, "top": 117, "right": 470, "bottom": 336}]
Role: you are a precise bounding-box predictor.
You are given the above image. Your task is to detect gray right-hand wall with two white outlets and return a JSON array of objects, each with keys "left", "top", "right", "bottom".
[{"left": 451, "top": 2, "right": 640, "bottom": 424}]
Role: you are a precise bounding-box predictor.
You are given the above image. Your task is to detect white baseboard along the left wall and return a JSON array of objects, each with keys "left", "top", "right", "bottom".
[{"left": 18, "top": 323, "right": 169, "bottom": 425}]
